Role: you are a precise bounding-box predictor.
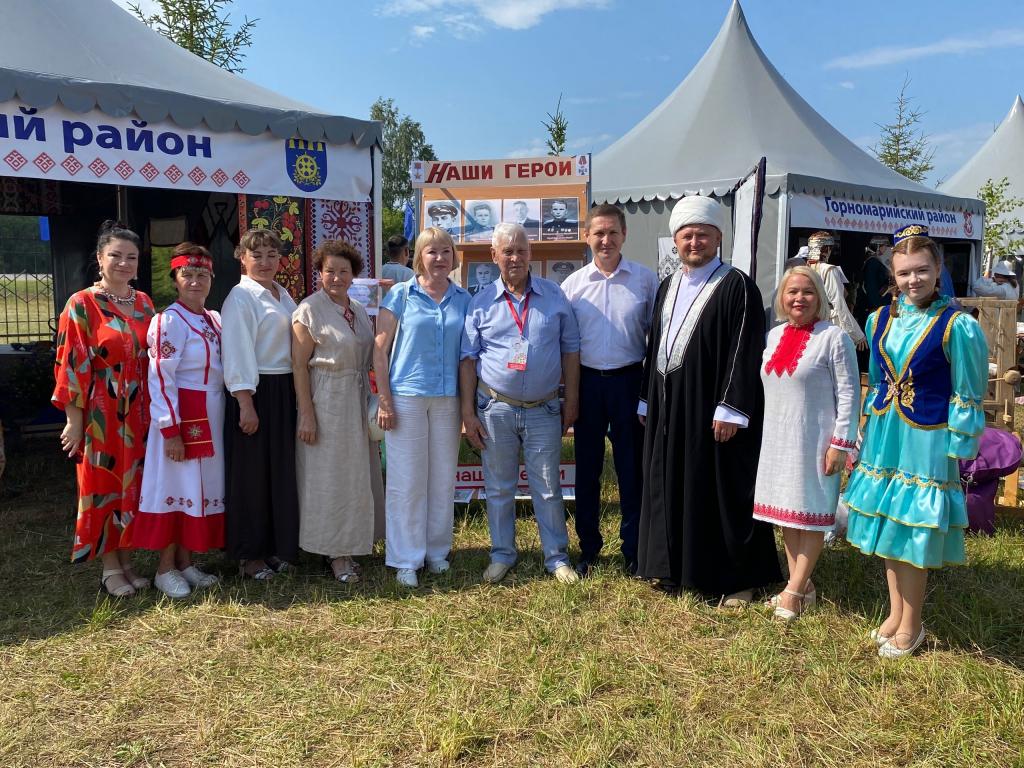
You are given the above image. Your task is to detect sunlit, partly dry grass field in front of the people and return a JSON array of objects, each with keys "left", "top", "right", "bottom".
[{"left": 0, "top": 438, "right": 1024, "bottom": 768}]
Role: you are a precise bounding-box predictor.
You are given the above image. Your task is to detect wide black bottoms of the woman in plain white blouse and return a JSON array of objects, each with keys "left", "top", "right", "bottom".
[{"left": 224, "top": 374, "right": 299, "bottom": 563}]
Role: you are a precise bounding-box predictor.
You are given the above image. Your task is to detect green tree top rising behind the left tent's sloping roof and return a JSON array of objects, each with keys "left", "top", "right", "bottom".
[{"left": 128, "top": 0, "right": 259, "bottom": 73}]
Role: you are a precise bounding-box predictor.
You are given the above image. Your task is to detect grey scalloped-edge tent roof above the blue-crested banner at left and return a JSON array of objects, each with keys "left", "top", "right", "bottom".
[{"left": 0, "top": 0, "right": 380, "bottom": 146}]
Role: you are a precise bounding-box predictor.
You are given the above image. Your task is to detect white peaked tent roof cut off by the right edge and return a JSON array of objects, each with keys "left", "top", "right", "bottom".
[{"left": 939, "top": 95, "right": 1024, "bottom": 224}]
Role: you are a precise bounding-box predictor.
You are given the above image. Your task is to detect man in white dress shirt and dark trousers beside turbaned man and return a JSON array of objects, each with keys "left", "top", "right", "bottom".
[{"left": 562, "top": 204, "right": 657, "bottom": 575}]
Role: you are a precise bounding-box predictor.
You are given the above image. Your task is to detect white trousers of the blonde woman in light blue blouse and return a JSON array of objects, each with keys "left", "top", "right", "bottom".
[{"left": 385, "top": 395, "right": 461, "bottom": 570}]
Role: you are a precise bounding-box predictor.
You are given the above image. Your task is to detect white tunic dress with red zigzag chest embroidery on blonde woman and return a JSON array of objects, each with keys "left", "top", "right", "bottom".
[{"left": 754, "top": 321, "right": 860, "bottom": 530}]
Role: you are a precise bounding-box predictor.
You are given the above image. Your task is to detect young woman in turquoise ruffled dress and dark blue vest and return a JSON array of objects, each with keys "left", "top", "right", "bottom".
[{"left": 846, "top": 224, "right": 988, "bottom": 658}]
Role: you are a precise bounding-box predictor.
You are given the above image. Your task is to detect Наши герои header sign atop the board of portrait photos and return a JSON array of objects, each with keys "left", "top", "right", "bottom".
[{"left": 409, "top": 155, "right": 590, "bottom": 189}]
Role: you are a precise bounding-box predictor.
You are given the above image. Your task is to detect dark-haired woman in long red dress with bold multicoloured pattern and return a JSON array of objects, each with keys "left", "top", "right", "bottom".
[{"left": 52, "top": 221, "right": 153, "bottom": 597}]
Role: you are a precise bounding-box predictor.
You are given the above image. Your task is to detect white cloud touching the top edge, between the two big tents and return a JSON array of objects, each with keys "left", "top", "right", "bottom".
[{"left": 381, "top": 0, "right": 610, "bottom": 37}]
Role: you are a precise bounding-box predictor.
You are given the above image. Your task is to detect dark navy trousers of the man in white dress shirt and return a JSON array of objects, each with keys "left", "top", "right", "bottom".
[{"left": 573, "top": 364, "right": 643, "bottom": 565}]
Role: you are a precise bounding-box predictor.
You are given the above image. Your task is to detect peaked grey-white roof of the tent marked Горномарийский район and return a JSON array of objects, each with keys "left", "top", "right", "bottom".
[{"left": 593, "top": 0, "right": 982, "bottom": 211}]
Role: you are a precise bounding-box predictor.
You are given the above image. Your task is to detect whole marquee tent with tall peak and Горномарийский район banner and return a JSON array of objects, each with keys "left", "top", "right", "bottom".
[{"left": 593, "top": 1, "right": 984, "bottom": 297}]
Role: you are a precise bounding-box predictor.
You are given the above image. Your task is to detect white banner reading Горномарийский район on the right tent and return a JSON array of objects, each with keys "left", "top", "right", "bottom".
[{"left": 790, "top": 194, "right": 983, "bottom": 240}]
